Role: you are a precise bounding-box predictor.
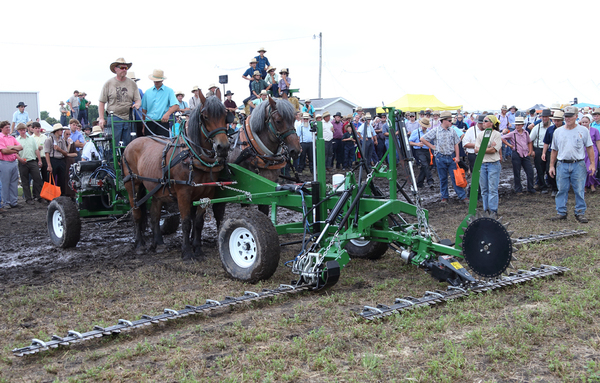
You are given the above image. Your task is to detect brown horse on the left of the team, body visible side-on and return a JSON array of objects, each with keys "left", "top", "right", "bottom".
[{"left": 122, "top": 91, "right": 229, "bottom": 260}]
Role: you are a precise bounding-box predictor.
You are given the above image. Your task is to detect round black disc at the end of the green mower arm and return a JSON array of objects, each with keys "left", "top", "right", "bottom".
[{"left": 462, "top": 217, "right": 512, "bottom": 278}]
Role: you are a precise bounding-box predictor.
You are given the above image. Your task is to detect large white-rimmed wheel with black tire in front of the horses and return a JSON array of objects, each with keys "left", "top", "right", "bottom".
[{"left": 219, "top": 209, "right": 280, "bottom": 283}]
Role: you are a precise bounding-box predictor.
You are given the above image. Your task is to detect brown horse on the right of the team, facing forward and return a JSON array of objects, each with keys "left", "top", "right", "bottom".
[{"left": 213, "top": 97, "right": 302, "bottom": 221}]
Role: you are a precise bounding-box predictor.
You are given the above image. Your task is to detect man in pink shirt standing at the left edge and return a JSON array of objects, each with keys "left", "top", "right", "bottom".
[{"left": 0, "top": 121, "right": 22, "bottom": 209}]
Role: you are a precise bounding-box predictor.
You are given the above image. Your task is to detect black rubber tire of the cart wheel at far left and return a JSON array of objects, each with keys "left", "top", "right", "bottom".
[{"left": 47, "top": 197, "right": 81, "bottom": 249}]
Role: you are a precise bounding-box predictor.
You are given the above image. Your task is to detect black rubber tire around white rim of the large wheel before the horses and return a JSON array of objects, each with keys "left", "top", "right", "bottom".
[{"left": 219, "top": 209, "right": 281, "bottom": 283}]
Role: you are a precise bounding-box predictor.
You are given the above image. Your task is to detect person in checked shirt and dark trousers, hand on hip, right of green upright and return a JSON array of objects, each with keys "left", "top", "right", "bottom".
[{"left": 501, "top": 117, "right": 535, "bottom": 194}]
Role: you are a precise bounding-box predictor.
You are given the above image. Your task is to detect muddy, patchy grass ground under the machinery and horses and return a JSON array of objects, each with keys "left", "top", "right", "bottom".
[{"left": 0, "top": 163, "right": 600, "bottom": 382}]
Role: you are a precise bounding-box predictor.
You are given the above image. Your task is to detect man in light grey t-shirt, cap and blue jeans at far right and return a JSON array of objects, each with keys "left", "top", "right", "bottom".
[{"left": 549, "top": 106, "right": 596, "bottom": 223}]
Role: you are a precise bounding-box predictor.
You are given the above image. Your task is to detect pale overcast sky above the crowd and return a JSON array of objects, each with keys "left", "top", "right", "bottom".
[{"left": 0, "top": 0, "right": 600, "bottom": 118}]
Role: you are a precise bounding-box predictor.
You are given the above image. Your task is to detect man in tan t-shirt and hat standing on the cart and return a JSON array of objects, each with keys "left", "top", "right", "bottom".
[{"left": 98, "top": 57, "right": 142, "bottom": 145}]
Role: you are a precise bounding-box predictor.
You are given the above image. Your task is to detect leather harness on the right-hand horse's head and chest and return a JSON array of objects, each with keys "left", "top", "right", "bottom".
[{"left": 234, "top": 106, "right": 296, "bottom": 170}]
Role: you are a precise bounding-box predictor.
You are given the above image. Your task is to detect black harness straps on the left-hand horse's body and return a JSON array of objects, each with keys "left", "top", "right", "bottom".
[{"left": 123, "top": 124, "right": 225, "bottom": 208}]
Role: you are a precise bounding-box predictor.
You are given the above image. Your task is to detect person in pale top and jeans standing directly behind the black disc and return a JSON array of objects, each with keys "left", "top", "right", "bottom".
[{"left": 475, "top": 114, "right": 502, "bottom": 219}]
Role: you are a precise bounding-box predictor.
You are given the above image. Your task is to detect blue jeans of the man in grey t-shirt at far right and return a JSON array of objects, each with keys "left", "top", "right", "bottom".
[{"left": 555, "top": 160, "right": 587, "bottom": 215}]
